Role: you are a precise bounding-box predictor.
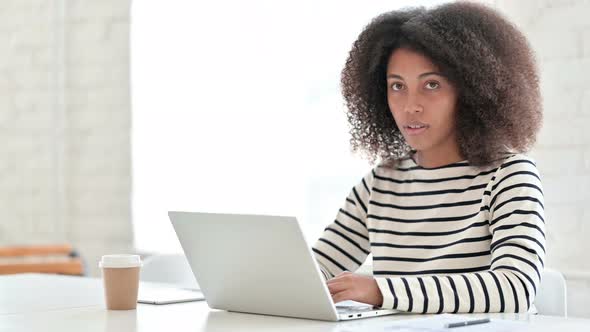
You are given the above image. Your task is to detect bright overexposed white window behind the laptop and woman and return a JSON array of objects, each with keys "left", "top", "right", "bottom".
[{"left": 131, "top": 0, "right": 448, "bottom": 252}]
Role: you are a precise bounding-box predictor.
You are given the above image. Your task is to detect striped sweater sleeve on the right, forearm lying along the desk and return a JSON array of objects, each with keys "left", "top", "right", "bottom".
[{"left": 376, "top": 155, "right": 545, "bottom": 313}]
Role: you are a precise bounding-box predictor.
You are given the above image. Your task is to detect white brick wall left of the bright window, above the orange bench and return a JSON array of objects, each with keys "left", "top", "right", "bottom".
[{"left": 0, "top": 0, "right": 133, "bottom": 275}]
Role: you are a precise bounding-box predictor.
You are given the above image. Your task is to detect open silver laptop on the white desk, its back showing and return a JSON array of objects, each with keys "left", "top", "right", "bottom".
[{"left": 168, "top": 211, "right": 398, "bottom": 321}]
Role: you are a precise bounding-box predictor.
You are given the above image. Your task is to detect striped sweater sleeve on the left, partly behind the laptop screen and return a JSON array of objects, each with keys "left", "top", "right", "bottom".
[{"left": 312, "top": 170, "right": 374, "bottom": 279}]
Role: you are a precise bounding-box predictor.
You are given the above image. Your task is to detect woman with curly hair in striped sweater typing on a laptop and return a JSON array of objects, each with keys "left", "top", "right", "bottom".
[{"left": 313, "top": 2, "right": 545, "bottom": 313}]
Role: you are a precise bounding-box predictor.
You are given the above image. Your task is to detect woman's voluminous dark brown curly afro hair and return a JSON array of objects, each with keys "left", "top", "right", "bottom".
[{"left": 341, "top": 2, "right": 542, "bottom": 166}]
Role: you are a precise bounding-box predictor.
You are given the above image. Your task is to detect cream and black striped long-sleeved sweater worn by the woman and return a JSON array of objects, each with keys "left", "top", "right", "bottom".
[{"left": 312, "top": 154, "right": 545, "bottom": 313}]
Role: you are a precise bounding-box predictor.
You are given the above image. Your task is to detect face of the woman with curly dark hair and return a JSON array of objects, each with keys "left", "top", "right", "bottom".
[{"left": 387, "top": 48, "right": 457, "bottom": 151}]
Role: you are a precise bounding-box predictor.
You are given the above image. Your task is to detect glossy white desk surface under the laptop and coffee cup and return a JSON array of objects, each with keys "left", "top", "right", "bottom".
[{"left": 0, "top": 274, "right": 590, "bottom": 332}]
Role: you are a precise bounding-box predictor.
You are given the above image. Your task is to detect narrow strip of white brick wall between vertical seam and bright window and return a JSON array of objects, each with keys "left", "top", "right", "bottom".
[{"left": 64, "top": 0, "right": 133, "bottom": 275}]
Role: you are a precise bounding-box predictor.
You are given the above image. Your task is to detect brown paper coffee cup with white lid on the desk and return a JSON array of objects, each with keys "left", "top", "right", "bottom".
[{"left": 98, "top": 255, "right": 142, "bottom": 310}]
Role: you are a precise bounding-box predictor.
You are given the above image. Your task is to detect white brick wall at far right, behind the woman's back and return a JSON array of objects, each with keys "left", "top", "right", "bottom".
[{"left": 492, "top": 0, "right": 590, "bottom": 317}]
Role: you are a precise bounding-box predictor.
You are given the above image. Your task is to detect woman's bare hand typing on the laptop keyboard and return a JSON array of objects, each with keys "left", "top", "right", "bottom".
[{"left": 326, "top": 271, "right": 383, "bottom": 307}]
